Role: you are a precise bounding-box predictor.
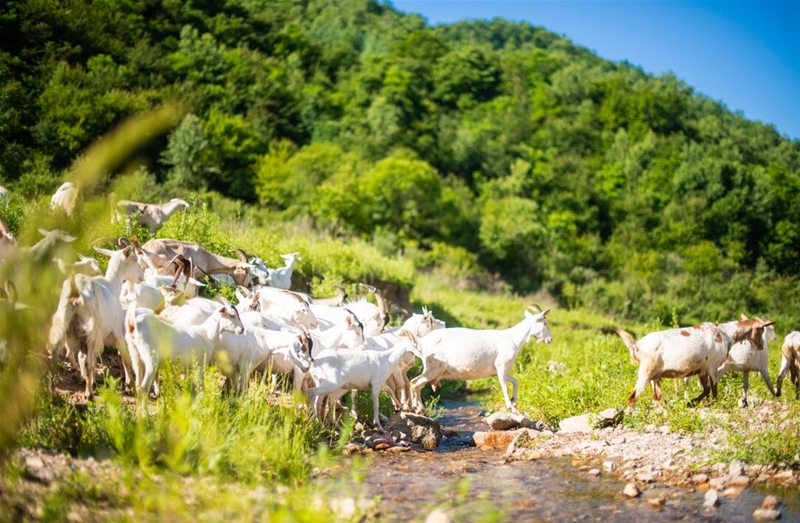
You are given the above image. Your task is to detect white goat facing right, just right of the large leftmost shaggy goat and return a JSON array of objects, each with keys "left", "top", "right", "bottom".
[{"left": 125, "top": 303, "right": 244, "bottom": 396}]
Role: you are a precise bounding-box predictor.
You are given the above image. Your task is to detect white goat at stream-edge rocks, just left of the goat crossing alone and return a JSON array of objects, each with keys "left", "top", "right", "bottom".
[{"left": 308, "top": 333, "right": 420, "bottom": 431}]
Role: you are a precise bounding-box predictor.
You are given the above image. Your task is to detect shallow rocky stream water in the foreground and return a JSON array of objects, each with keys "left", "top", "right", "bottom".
[{"left": 362, "top": 401, "right": 800, "bottom": 523}]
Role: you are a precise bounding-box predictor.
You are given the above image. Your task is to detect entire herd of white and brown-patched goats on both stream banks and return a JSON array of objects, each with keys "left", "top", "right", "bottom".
[{"left": 0, "top": 187, "right": 800, "bottom": 429}]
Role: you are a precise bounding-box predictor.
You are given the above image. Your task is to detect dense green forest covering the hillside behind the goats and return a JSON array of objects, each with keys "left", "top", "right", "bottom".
[{"left": 0, "top": 0, "right": 800, "bottom": 328}]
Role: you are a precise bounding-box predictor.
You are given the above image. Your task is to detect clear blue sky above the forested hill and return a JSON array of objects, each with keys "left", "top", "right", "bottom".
[{"left": 392, "top": 0, "right": 800, "bottom": 140}]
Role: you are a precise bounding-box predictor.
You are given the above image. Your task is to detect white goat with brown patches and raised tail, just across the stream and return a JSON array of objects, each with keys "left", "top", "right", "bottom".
[{"left": 615, "top": 319, "right": 773, "bottom": 412}]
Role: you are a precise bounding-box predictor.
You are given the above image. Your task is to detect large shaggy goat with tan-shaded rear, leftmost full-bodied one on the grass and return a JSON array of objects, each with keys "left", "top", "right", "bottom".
[{"left": 49, "top": 247, "right": 143, "bottom": 398}]
